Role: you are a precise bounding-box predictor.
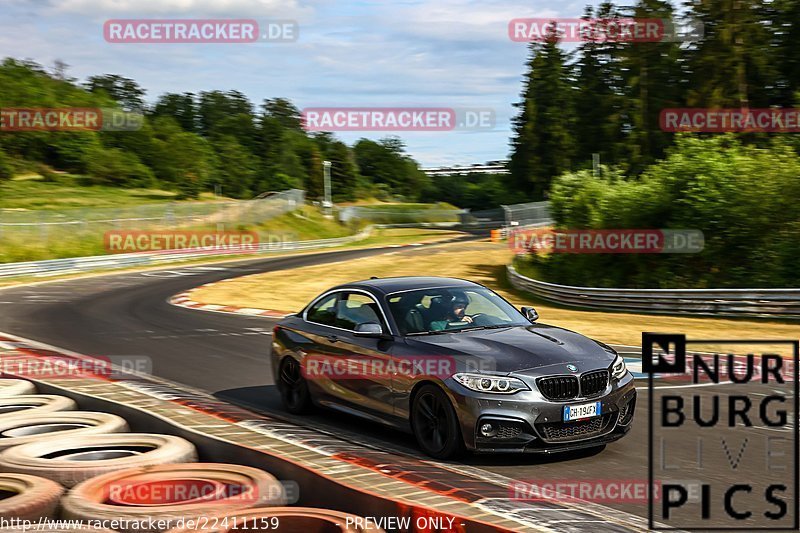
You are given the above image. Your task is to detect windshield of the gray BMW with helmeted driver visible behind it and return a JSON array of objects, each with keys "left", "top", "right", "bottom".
[{"left": 388, "top": 287, "right": 530, "bottom": 335}]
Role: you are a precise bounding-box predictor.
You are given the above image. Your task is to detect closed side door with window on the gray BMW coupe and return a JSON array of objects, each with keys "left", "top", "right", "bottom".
[{"left": 322, "top": 290, "right": 393, "bottom": 416}]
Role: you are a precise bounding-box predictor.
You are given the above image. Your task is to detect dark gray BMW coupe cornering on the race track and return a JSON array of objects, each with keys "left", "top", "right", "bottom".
[{"left": 271, "top": 277, "right": 636, "bottom": 459}]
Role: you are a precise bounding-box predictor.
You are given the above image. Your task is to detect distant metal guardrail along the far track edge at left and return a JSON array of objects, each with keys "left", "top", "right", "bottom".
[{"left": 0, "top": 228, "right": 370, "bottom": 278}]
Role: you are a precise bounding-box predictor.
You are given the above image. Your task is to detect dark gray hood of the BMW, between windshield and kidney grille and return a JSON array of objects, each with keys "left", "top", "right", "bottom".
[{"left": 408, "top": 324, "right": 615, "bottom": 374}]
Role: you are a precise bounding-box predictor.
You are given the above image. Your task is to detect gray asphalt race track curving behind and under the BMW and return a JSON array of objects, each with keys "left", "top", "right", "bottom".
[{"left": 0, "top": 242, "right": 794, "bottom": 528}]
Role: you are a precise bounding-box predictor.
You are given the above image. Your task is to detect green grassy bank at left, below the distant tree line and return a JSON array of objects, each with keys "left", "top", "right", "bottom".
[{"left": 0, "top": 174, "right": 455, "bottom": 263}]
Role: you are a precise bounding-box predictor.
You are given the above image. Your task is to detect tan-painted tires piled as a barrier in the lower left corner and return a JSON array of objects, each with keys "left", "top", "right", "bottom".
[{"left": 0, "top": 379, "right": 382, "bottom": 533}]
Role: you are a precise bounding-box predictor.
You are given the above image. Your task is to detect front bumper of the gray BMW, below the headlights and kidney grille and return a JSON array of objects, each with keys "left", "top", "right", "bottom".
[{"left": 447, "top": 373, "right": 636, "bottom": 453}]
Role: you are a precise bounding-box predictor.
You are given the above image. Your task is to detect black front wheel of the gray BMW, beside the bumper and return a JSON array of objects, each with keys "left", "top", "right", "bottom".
[{"left": 411, "top": 385, "right": 464, "bottom": 459}]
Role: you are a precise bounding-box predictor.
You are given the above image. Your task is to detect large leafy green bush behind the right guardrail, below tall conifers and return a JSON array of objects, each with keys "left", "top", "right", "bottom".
[{"left": 527, "top": 135, "right": 800, "bottom": 288}]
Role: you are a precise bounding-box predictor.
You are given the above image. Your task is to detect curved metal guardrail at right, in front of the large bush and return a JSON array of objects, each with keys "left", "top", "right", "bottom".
[{"left": 507, "top": 265, "right": 800, "bottom": 319}]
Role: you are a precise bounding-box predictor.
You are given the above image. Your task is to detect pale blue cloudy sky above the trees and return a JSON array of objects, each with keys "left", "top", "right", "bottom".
[{"left": 0, "top": 0, "right": 616, "bottom": 166}]
